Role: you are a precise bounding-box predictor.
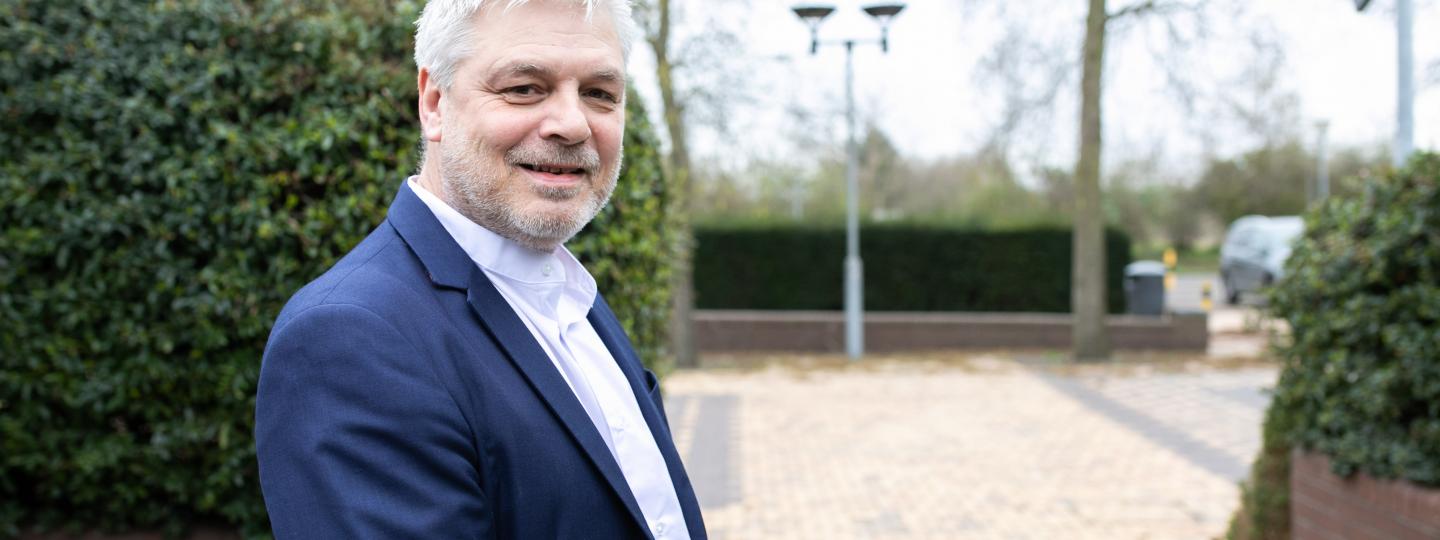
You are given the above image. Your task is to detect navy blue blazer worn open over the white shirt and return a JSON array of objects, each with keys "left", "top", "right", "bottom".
[{"left": 255, "top": 186, "right": 706, "bottom": 540}]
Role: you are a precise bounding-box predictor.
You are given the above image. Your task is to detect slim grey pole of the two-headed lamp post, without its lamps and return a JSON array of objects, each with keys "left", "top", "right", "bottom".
[{"left": 845, "top": 40, "right": 865, "bottom": 360}]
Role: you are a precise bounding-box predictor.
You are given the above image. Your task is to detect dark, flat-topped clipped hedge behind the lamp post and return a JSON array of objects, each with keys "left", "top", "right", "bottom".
[{"left": 694, "top": 225, "right": 1130, "bottom": 312}]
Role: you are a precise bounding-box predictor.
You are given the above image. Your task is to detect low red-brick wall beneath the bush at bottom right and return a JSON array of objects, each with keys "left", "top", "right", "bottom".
[{"left": 1290, "top": 451, "right": 1440, "bottom": 540}]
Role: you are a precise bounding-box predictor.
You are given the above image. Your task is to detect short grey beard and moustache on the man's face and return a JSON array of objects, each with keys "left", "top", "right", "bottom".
[{"left": 441, "top": 141, "right": 624, "bottom": 252}]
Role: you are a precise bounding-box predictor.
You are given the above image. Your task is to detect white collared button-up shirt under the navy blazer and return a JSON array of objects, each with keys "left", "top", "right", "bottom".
[{"left": 408, "top": 176, "right": 690, "bottom": 539}]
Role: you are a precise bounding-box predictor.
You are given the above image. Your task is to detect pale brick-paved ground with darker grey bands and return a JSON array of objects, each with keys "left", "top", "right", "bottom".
[{"left": 665, "top": 354, "right": 1276, "bottom": 540}]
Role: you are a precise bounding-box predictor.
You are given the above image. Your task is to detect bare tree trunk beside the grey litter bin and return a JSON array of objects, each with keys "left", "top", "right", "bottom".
[{"left": 1070, "top": 0, "right": 1110, "bottom": 361}]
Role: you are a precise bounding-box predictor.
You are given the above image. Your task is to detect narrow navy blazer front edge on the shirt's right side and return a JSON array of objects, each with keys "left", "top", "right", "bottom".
[{"left": 586, "top": 295, "right": 706, "bottom": 539}]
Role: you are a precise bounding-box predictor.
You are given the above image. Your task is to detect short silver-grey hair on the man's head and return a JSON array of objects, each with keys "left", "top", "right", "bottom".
[{"left": 415, "top": 0, "right": 639, "bottom": 89}]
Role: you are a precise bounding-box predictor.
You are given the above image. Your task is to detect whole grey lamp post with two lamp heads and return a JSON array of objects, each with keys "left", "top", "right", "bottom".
[{"left": 793, "top": 4, "right": 904, "bottom": 360}]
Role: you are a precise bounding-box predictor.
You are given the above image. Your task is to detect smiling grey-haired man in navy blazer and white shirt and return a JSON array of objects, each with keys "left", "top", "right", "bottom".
[{"left": 255, "top": 0, "right": 706, "bottom": 539}]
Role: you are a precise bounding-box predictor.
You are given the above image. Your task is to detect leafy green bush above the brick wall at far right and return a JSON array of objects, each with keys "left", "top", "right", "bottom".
[{"left": 1270, "top": 153, "right": 1440, "bottom": 485}]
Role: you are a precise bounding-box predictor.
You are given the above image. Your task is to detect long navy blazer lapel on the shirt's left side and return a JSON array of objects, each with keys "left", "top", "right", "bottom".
[{"left": 387, "top": 184, "right": 649, "bottom": 534}]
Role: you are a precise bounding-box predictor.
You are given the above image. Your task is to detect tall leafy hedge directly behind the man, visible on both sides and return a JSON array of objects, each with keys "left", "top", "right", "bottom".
[{"left": 0, "top": 0, "right": 670, "bottom": 537}]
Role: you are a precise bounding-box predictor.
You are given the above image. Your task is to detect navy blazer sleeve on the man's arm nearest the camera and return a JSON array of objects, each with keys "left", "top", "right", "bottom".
[{"left": 255, "top": 304, "right": 494, "bottom": 539}]
